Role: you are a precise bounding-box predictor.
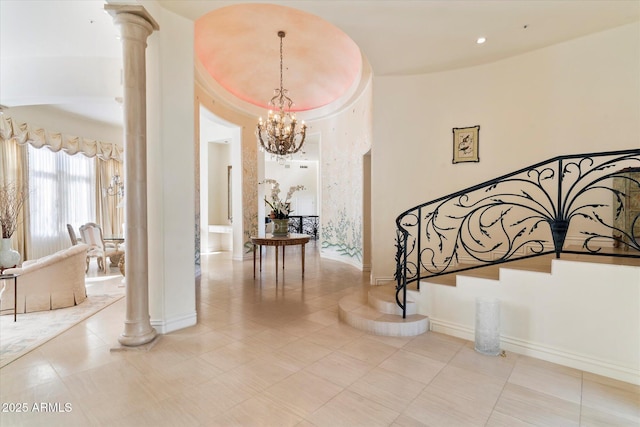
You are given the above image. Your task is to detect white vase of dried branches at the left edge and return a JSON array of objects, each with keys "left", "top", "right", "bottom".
[{"left": 0, "top": 183, "right": 28, "bottom": 269}]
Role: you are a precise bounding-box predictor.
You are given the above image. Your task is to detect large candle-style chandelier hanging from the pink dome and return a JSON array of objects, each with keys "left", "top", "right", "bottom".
[{"left": 256, "top": 31, "right": 307, "bottom": 161}]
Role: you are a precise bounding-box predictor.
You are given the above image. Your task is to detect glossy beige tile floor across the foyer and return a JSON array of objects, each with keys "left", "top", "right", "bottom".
[{"left": 0, "top": 243, "right": 640, "bottom": 427}]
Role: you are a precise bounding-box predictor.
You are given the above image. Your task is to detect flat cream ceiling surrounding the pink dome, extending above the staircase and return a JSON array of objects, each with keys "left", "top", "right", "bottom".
[{"left": 164, "top": 0, "right": 640, "bottom": 75}]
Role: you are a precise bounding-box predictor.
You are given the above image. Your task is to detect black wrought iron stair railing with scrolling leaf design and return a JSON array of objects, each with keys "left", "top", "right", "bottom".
[{"left": 395, "top": 149, "right": 640, "bottom": 317}]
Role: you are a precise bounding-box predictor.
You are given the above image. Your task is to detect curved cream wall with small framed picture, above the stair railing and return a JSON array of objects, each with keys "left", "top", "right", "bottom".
[{"left": 372, "top": 23, "right": 640, "bottom": 282}]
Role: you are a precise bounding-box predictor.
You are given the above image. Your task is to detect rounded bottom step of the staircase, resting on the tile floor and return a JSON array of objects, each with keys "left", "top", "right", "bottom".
[{"left": 338, "top": 287, "right": 429, "bottom": 337}]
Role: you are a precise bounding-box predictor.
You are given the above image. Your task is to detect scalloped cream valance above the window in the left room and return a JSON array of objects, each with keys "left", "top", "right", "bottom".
[{"left": 0, "top": 115, "right": 123, "bottom": 162}]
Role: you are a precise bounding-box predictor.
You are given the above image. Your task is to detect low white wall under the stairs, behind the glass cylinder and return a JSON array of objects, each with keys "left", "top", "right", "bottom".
[{"left": 418, "top": 259, "right": 640, "bottom": 384}]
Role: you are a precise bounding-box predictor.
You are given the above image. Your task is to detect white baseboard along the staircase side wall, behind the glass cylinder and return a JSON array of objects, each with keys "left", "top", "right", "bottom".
[{"left": 429, "top": 317, "right": 640, "bottom": 385}]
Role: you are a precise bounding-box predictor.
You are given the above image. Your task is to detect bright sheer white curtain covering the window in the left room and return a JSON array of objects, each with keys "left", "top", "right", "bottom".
[{"left": 28, "top": 145, "right": 96, "bottom": 259}]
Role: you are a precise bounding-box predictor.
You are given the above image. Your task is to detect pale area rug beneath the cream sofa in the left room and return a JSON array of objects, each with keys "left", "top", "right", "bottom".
[{"left": 0, "top": 278, "right": 124, "bottom": 368}]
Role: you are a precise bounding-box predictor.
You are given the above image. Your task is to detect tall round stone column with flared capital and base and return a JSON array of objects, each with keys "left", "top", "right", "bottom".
[{"left": 104, "top": 4, "right": 159, "bottom": 346}]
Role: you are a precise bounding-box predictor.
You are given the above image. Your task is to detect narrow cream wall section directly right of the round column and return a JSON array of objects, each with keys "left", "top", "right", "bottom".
[{"left": 145, "top": 3, "right": 197, "bottom": 333}]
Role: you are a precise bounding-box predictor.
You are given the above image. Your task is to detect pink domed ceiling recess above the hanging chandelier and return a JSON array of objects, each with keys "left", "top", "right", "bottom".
[{"left": 195, "top": 4, "right": 362, "bottom": 111}]
